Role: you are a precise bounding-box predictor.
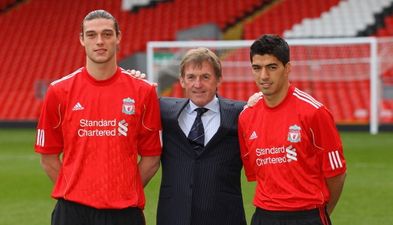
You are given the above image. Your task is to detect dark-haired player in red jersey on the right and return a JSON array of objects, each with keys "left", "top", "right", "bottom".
[{"left": 239, "top": 35, "right": 346, "bottom": 225}]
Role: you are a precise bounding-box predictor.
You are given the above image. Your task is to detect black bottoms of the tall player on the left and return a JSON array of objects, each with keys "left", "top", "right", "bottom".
[{"left": 51, "top": 199, "right": 146, "bottom": 225}]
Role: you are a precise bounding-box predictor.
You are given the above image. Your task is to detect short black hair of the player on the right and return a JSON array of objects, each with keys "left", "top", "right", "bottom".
[{"left": 250, "top": 34, "right": 290, "bottom": 65}]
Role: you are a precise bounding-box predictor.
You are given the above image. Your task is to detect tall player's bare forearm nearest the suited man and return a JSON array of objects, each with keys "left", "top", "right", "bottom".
[{"left": 138, "top": 156, "right": 160, "bottom": 187}]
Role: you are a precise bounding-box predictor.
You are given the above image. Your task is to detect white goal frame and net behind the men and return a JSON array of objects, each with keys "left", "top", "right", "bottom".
[{"left": 147, "top": 38, "right": 393, "bottom": 134}]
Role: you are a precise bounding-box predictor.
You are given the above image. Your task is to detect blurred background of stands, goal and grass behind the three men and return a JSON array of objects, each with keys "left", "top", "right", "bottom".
[{"left": 0, "top": 0, "right": 393, "bottom": 225}]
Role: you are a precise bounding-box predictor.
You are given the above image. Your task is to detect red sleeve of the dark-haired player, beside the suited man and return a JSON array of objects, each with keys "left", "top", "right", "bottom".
[{"left": 238, "top": 113, "right": 256, "bottom": 181}]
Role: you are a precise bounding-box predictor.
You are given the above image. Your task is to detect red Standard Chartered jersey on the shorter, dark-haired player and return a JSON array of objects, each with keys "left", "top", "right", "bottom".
[{"left": 239, "top": 86, "right": 346, "bottom": 211}]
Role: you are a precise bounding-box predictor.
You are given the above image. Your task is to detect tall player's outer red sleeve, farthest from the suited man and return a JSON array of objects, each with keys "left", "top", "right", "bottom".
[{"left": 35, "top": 86, "right": 63, "bottom": 154}]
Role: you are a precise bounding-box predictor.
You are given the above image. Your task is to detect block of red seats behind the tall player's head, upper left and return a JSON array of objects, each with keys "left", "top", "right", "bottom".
[{"left": 0, "top": 0, "right": 263, "bottom": 121}]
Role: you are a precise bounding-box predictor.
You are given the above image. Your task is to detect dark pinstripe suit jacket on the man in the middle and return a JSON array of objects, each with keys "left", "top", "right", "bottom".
[{"left": 157, "top": 98, "right": 246, "bottom": 225}]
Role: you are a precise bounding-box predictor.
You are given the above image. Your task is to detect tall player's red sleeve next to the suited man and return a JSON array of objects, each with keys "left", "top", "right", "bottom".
[{"left": 138, "top": 86, "right": 162, "bottom": 156}]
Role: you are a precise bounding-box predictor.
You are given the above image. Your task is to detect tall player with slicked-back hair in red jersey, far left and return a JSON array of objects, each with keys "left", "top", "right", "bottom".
[{"left": 35, "top": 10, "right": 161, "bottom": 225}]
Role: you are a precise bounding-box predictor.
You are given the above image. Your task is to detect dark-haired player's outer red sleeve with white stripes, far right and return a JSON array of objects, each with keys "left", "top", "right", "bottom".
[{"left": 311, "top": 107, "right": 346, "bottom": 178}]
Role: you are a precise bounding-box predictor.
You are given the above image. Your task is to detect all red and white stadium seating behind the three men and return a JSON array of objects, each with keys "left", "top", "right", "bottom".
[{"left": 0, "top": 0, "right": 393, "bottom": 123}]
